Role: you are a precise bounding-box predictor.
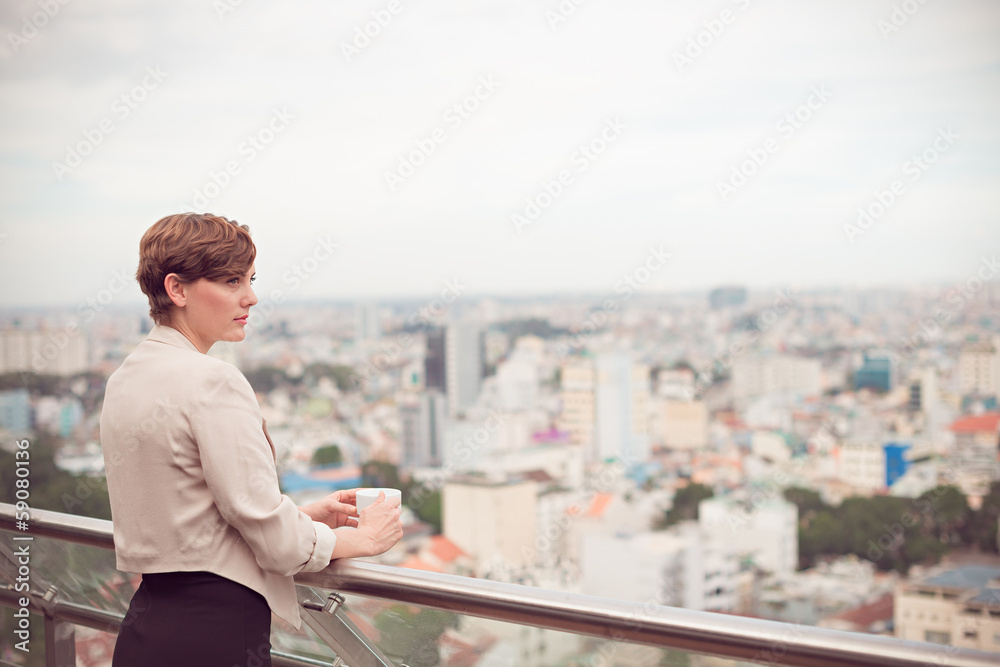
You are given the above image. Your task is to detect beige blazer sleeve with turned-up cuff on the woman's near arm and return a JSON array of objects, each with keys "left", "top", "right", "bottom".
[{"left": 189, "top": 363, "right": 337, "bottom": 576}]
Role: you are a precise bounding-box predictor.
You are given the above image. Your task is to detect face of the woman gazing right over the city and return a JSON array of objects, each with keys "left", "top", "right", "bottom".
[{"left": 179, "top": 265, "right": 257, "bottom": 352}]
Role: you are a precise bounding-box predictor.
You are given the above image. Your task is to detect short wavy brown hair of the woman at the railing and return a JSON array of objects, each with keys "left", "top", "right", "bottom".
[{"left": 135, "top": 213, "right": 257, "bottom": 324}]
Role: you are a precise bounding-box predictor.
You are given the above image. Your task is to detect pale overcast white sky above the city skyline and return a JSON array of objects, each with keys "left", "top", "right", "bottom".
[{"left": 0, "top": 0, "right": 1000, "bottom": 306}]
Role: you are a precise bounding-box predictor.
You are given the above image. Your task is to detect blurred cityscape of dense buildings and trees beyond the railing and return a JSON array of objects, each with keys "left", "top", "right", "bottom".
[{"left": 0, "top": 276, "right": 1000, "bottom": 665}]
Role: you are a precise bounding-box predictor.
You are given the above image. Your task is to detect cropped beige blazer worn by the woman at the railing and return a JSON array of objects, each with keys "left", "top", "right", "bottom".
[{"left": 101, "top": 326, "right": 337, "bottom": 627}]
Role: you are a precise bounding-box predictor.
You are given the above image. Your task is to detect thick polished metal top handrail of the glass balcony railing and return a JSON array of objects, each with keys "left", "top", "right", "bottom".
[{"left": 0, "top": 504, "right": 1000, "bottom": 667}]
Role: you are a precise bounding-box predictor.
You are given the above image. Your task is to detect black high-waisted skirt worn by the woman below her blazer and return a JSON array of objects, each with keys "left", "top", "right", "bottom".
[{"left": 111, "top": 572, "right": 271, "bottom": 667}]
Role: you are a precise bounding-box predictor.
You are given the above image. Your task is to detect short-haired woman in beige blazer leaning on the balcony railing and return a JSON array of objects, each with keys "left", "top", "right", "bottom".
[{"left": 101, "top": 213, "right": 402, "bottom": 667}]
